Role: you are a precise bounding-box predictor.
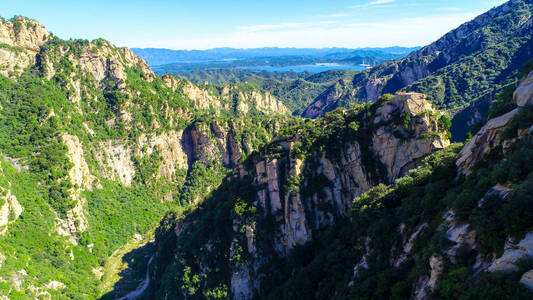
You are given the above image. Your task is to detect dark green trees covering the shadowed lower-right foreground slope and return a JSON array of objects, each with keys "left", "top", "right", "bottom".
[{"left": 251, "top": 138, "right": 533, "bottom": 299}]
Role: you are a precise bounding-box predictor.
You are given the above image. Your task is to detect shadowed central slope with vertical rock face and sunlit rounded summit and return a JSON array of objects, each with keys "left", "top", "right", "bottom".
[{"left": 150, "top": 94, "right": 449, "bottom": 299}]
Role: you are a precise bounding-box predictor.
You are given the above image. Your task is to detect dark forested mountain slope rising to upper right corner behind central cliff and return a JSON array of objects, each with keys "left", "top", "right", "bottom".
[{"left": 302, "top": 0, "right": 533, "bottom": 138}]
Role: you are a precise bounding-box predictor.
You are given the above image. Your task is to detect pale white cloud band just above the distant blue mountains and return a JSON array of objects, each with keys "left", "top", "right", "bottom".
[{"left": 132, "top": 11, "right": 481, "bottom": 49}]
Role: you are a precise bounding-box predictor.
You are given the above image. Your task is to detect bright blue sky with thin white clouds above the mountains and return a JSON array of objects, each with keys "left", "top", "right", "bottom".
[{"left": 0, "top": 0, "right": 505, "bottom": 49}]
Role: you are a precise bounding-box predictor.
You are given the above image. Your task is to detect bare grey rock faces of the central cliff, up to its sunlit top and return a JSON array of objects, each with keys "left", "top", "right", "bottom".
[{"left": 224, "top": 94, "right": 449, "bottom": 299}]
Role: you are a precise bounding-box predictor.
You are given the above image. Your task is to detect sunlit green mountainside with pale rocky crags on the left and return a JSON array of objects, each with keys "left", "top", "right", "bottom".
[{"left": 0, "top": 17, "right": 296, "bottom": 299}]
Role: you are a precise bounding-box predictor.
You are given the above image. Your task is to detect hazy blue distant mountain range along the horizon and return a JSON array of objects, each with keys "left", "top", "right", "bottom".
[{"left": 131, "top": 47, "right": 419, "bottom": 66}]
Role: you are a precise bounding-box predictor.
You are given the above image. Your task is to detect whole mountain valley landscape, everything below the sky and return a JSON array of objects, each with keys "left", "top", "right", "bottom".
[{"left": 0, "top": 0, "right": 533, "bottom": 300}]
